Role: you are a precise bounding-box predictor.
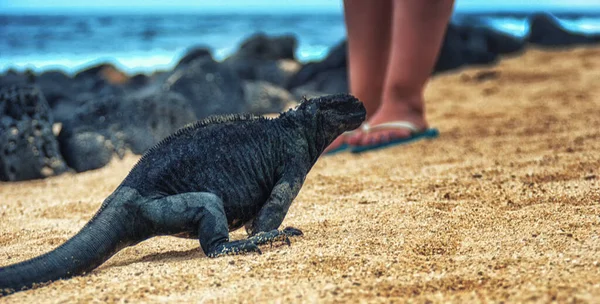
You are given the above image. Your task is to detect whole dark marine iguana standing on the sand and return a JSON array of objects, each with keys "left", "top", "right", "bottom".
[{"left": 0, "top": 94, "right": 366, "bottom": 295}]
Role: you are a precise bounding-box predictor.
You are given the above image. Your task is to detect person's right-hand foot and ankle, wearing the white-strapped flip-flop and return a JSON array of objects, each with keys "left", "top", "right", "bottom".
[{"left": 346, "top": 95, "right": 427, "bottom": 146}]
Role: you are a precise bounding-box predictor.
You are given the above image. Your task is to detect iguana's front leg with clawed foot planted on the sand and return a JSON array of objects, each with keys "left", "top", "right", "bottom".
[{"left": 246, "top": 175, "right": 304, "bottom": 245}]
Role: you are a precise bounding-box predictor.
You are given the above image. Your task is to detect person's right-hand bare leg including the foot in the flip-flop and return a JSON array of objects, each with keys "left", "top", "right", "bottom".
[{"left": 347, "top": 0, "right": 454, "bottom": 150}]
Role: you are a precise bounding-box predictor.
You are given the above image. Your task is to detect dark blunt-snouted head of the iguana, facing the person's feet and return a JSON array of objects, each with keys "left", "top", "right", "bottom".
[{"left": 296, "top": 94, "right": 367, "bottom": 149}]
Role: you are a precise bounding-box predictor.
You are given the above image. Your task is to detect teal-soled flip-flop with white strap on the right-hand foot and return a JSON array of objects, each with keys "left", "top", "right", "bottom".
[{"left": 346, "top": 121, "right": 440, "bottom": 153}]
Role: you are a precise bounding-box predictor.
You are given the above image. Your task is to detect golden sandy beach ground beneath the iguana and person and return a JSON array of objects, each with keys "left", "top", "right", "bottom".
[{"left": 0, "top": 48, "right": 600, "bottom": 303}]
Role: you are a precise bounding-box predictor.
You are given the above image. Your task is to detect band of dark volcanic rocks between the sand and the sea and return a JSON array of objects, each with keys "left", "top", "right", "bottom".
[{"left": 0, "top": 14, "right": 600, "bottom": 181}]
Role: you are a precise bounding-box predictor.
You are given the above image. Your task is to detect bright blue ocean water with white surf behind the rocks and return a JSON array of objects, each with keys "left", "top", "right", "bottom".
[{"left": 0, "top": 12, "right": 600, "bottom": 73}]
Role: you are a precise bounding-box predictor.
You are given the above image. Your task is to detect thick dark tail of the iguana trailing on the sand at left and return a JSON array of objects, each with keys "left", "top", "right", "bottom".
[{"left": 0, "top": 202, "right": 141, "bottom": 297}]
